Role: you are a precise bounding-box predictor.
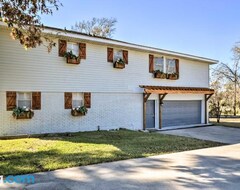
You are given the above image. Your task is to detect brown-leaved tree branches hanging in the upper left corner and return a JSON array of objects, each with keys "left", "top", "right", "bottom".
[{"left": 0, "top": 0, "right": 62, "bottom": 51}]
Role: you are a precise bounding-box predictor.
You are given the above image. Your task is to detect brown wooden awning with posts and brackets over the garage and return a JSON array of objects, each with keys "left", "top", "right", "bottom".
[{"left": 140, "top": 85, "right": 214, "bottom": 130}]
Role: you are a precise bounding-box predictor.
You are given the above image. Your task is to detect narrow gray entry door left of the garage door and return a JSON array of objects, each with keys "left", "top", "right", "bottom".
[{"left": 146, "top": 100, "right": 155, "bottom": 128}]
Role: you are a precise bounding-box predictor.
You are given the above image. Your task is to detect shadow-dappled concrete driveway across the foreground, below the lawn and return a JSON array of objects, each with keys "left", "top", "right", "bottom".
[{"left": 0, "top": 144, "right": 240, "bottom": 190}]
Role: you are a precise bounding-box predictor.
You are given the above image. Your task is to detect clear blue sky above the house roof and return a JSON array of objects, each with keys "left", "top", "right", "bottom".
[{"left": 42, "top": 0, "right": 240, "bottom": 63}]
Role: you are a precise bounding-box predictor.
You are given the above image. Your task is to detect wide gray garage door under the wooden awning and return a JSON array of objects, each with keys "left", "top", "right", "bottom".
[{"left": 162, "top": 100, "right": 201, "bottom": 127}]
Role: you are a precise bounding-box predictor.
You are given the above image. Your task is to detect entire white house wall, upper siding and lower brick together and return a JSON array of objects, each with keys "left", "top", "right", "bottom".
[{"left": 0, "top": 29, "right": 209, "bottom": 136}]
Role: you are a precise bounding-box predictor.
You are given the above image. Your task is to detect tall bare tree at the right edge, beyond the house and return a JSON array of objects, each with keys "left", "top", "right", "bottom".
[{"left": 214, "top": 45, "right": 240, "bottom": 116}]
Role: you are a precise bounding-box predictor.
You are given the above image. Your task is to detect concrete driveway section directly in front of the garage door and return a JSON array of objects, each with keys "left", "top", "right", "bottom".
[{"left": 158, "top": 126, "right": 240, "bottom": 144}]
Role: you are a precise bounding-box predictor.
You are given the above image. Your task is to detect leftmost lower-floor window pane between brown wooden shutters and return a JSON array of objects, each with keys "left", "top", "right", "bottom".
[{"left": 17, "top": 92, "right": 32, "bottom": 108}]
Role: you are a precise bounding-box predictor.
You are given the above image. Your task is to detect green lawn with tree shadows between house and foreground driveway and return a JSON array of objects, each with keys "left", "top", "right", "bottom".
[{"left": 0, "top": 130, "right": 222, "bottom": 175}]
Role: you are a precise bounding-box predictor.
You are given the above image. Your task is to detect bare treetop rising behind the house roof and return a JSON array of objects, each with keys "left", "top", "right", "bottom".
[{"left": 72, "top": 17, "right": 117, "bottom": 38}]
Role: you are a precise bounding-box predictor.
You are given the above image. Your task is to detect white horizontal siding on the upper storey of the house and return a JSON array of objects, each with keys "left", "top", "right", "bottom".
[{"left": 0, "top": 30, "right": 209, "bottom": 92}]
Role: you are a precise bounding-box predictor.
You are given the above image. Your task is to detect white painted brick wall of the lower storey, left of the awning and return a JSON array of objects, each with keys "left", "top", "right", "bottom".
[{"left": 0, "top": 92, "right": 142, "bottom": 136}]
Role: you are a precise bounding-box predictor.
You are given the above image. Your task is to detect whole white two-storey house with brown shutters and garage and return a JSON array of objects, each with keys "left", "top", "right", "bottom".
[{"left": 0, "top": 24, "right": 217, "bottom": 136}]
